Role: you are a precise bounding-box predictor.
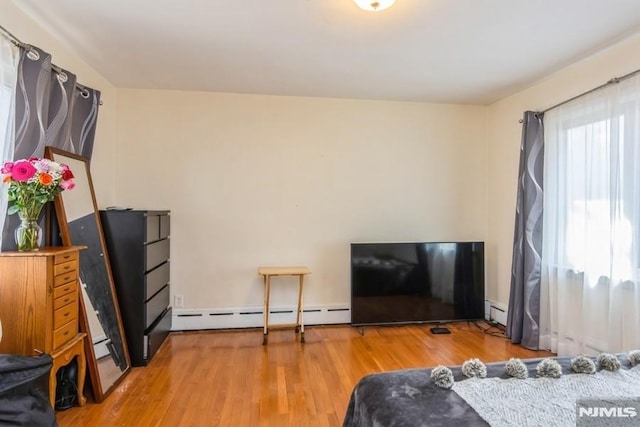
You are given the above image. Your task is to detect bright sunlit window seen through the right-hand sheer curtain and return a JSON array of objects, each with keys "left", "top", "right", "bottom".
[{"left": 543, "top": 83, "right": 640, "bottom": 286}]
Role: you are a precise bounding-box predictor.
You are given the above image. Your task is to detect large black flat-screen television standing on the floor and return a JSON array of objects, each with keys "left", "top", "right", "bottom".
[{"left": 351, "top": 242, "right": 484, "bottom": 326}]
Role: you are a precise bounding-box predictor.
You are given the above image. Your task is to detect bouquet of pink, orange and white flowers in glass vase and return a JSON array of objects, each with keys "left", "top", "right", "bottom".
[{"left": 0, "top": 157, "right": 75, "bottom": 251}]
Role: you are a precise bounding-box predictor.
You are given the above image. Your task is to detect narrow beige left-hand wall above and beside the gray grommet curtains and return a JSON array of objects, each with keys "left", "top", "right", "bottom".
[{"left": 0, "top": 1, "right": 117, "bottom": 206}]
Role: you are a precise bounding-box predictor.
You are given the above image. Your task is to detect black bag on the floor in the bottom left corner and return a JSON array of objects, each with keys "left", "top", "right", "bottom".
[{"left": 0, "top": 354, "right": 58, "bottom": 427}]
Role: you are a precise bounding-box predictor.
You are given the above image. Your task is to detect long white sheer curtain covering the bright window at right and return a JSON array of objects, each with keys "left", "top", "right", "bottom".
[{"left": 540, "top": 74, "right": 640, "bottom": 355}]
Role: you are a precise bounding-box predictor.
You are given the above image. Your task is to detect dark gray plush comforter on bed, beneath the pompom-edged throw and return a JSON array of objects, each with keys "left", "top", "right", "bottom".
[{"left": 343, "top": 355, "right": 628, "bottom": 427}]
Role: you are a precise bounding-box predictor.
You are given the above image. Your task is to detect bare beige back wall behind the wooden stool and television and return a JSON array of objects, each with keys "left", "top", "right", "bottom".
[{"left": 116, "top": 89, "right": 487, "bottom": 308}]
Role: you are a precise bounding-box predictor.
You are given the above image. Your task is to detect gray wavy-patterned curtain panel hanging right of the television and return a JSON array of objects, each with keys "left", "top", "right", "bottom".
[{"left": 507, "top": 111, "right": 544, "bottom": 349}]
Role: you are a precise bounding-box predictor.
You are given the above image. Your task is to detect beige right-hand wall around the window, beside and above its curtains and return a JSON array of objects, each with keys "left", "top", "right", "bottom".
[{"left": 487, "top": 34, "right": 640, "bottom": 304}]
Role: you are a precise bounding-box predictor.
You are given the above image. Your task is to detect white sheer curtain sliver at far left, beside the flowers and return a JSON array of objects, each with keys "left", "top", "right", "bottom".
[{"left": 0, "top": 35, "right": 19, "bottom": 251}]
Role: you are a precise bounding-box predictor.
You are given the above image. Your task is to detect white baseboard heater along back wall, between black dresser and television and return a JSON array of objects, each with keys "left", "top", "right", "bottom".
[{"left": 171, "top": 305, "right": 351, "bottom": 331}]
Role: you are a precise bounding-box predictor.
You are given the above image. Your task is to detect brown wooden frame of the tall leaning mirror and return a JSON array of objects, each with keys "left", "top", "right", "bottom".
[{"left": 45, "top": 147, "right": 131, "bottom": 403}]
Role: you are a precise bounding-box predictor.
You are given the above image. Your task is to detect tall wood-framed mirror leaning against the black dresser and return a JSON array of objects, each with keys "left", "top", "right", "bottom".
[{"left": 45, "top": 147, "right": 131, "bottom": 402}]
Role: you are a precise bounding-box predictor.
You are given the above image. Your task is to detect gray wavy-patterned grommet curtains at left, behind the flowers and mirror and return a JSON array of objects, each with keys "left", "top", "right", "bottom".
[{"left": 0, "top": 46, "right": 100, "bottom": 251}]
